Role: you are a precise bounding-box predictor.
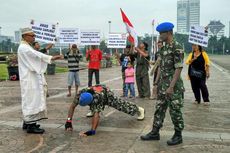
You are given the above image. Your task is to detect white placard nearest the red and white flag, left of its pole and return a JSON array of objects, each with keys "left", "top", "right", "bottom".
[{"left": 108, "top": 33, "right": 127, "bottom": 48}]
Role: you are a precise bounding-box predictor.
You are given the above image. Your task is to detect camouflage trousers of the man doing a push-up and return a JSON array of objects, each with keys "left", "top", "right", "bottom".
[{"left": 107, "top": 92, "right": 139, "bottom": 116}]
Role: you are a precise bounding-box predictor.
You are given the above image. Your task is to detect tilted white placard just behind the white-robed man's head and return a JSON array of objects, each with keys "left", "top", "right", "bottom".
[{"left": 30, "top": 20, "right": 57, "bottom": 43}]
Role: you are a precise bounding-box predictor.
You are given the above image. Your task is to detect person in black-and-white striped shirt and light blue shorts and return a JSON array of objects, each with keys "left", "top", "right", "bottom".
[{"left": 66, "top": 44, "right": 82, "bottom": 97}]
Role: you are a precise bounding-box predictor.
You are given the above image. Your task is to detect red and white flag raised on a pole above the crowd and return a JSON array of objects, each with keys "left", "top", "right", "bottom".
[{"left": 121, "top": 9, "right": 138, "bottom": 47}]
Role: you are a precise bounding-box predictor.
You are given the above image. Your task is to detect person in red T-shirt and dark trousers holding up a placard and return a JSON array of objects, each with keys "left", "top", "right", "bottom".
[{"left": 86, "top": 45, "right": 102, "bottom": 87}]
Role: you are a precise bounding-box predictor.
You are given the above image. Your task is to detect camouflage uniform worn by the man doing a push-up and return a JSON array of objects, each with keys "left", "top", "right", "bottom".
[{"left": 74, "top": 85, "right": 139, "bottom": 116}]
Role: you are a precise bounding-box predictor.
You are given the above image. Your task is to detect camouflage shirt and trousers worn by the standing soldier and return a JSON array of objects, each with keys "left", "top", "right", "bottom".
[{"left": 153, "top": 40, "right": 184, "bottom": 131}]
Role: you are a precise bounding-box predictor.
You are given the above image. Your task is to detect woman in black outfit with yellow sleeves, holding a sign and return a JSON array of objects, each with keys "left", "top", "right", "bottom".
[{"left": 186, "top": 44, "right": 210, "bottom": 105}]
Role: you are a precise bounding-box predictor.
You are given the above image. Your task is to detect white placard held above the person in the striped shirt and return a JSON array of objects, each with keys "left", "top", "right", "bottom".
[{"left": 58, "top": 28, "right": 79, "bottom": 44}]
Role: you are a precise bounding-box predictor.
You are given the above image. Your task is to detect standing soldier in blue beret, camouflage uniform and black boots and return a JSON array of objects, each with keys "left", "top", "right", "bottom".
[{"left": 141, "top": 22, "right": 184, "bottom": 145}]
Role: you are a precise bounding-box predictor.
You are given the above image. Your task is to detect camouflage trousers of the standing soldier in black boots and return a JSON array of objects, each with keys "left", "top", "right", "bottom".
[{"left": 153, "top": 93, "right": 184, "bottom": 131}]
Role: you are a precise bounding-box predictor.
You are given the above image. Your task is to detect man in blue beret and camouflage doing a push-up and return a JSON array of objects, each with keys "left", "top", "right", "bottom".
[{"left": 65, "top": 85, "right": 145, "bottom": 136}]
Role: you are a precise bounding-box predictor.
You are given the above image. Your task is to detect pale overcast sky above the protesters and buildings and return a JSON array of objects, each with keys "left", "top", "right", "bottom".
[{"left": 0, "top": 0, "right": 230, "bottom": 37}]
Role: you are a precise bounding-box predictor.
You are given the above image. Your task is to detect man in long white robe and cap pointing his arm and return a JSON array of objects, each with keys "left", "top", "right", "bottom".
[{"left": 18, "top": 28, "right": 63, "bottom": 134}]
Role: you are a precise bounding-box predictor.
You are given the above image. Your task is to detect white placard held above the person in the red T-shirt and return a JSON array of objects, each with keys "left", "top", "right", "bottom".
[{"left": 80, "top": 30, "right": 101, "bottom": 45}]
